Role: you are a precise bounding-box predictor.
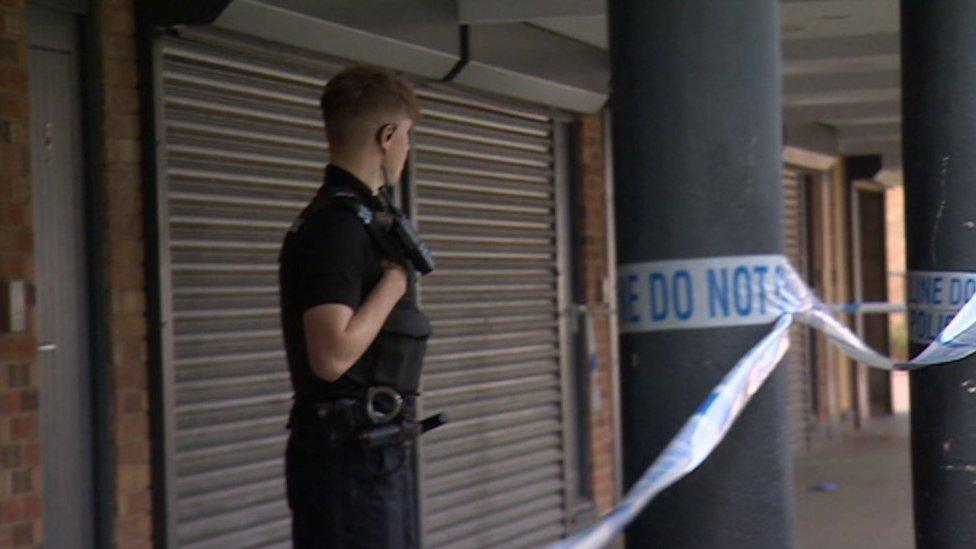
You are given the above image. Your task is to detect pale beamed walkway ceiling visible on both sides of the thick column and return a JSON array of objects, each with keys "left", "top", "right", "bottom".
[{"left": 457, "top": 0, "right": 901, "bottom": 183}]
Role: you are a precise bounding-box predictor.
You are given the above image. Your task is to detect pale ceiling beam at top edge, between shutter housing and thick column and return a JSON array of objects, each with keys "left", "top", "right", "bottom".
[{"left": 457, "top": 0, "right": 607, "bottom": 24}]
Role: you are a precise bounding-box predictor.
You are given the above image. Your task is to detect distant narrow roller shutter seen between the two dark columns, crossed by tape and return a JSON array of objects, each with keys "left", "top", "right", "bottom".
[{"left": 783, "top": 168, "right": 813, "bottom": 452}]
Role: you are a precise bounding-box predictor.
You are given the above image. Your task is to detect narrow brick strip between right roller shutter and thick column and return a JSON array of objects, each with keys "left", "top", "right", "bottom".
[{"left": 578, "top": 113, "right": 615, "bottom": 512}]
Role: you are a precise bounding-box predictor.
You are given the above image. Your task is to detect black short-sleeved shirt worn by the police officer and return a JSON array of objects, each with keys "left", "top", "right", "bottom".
[{"left": 278, "top": 165, "right": 383, "bottom": 401}]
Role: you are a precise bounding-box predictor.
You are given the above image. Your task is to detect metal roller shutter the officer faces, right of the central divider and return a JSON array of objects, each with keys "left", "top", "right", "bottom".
[{"left": 413, "top": 85, "right": 568, "bottom": 548}]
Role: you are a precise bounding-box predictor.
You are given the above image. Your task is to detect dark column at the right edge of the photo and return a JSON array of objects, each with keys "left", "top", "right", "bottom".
[{"left": 901, "top": 0, "right": 976, "bottom": 548}]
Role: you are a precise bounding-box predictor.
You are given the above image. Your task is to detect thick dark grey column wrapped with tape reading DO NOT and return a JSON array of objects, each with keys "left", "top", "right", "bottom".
[{"left": 609, "top": 0, "right": 793, "bottom": 549}]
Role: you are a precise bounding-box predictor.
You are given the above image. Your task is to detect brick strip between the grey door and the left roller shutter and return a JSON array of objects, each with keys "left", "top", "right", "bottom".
[{"left": 93, "top": 0, "right": 153, "bottom": 548}]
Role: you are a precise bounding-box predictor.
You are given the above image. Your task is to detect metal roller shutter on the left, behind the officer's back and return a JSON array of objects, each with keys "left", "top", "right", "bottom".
[{"left": 155, "top": 32, "right": 342, "bottom": 547}]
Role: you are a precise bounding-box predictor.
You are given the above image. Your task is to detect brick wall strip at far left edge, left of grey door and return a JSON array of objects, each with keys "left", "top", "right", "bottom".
[{"left": 0, "top": 0, "right": 44, "bottom": 547}]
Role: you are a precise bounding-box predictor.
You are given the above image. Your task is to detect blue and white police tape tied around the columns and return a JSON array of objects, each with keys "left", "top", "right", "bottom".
[{"left": 553, "top": 256, "right": 976, "bottom": 549}]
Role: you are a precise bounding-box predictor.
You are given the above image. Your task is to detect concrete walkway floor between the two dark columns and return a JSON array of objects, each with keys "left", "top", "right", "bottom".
[{"left": 794, "top": 415, "right": 914, "bottom": 549}]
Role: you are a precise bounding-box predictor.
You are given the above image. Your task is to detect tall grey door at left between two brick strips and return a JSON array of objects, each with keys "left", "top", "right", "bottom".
[{"left": 28, "top": 5, "right": 94, "bottom": 548}]
